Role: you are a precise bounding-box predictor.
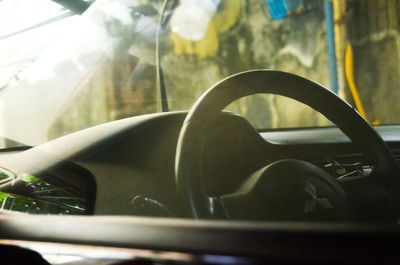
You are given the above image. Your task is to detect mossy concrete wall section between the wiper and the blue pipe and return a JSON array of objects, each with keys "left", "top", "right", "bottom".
[{"left": 163, "top": 0, "right": 329, "bottom": 128}]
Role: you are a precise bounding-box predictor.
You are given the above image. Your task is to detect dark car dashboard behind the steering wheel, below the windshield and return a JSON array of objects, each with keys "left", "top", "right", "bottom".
[{"left": 0, "top": 112, "right": 392, "bottom": 217}]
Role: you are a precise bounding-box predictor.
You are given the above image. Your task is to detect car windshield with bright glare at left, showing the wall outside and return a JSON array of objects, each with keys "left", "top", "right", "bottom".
[{"left": 0, "top": 0, "right": 394, "bottom": 145}]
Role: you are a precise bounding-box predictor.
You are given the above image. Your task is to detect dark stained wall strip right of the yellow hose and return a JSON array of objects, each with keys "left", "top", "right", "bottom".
[{"left": 347, "top": 0, "right": 400, "bottom": 124}]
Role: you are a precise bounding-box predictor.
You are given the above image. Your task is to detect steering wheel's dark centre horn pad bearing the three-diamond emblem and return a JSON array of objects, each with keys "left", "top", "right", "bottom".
[{"left": 221, "top": 160, "right": 347, "bottom": 221}]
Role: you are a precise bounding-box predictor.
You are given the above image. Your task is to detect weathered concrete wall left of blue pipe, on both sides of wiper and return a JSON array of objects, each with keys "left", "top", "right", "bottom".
[{"left": 49, "top": 0, "right": 329, "bottom": 138}]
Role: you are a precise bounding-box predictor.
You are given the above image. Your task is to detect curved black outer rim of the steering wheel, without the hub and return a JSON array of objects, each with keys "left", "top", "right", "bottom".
[{"left": 175, "top": 70, "right": 400, "bottom": 219}]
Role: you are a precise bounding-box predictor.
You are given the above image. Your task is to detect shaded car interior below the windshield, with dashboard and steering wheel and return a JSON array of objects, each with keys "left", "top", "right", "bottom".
[{"left": 0, "top": 0, "right": 400, "bottom": 265}]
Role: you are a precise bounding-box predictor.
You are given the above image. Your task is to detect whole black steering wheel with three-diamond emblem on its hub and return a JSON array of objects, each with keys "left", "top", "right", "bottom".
[{"left": 175, "top": 70, "right": 400, "bottom": 221}]
